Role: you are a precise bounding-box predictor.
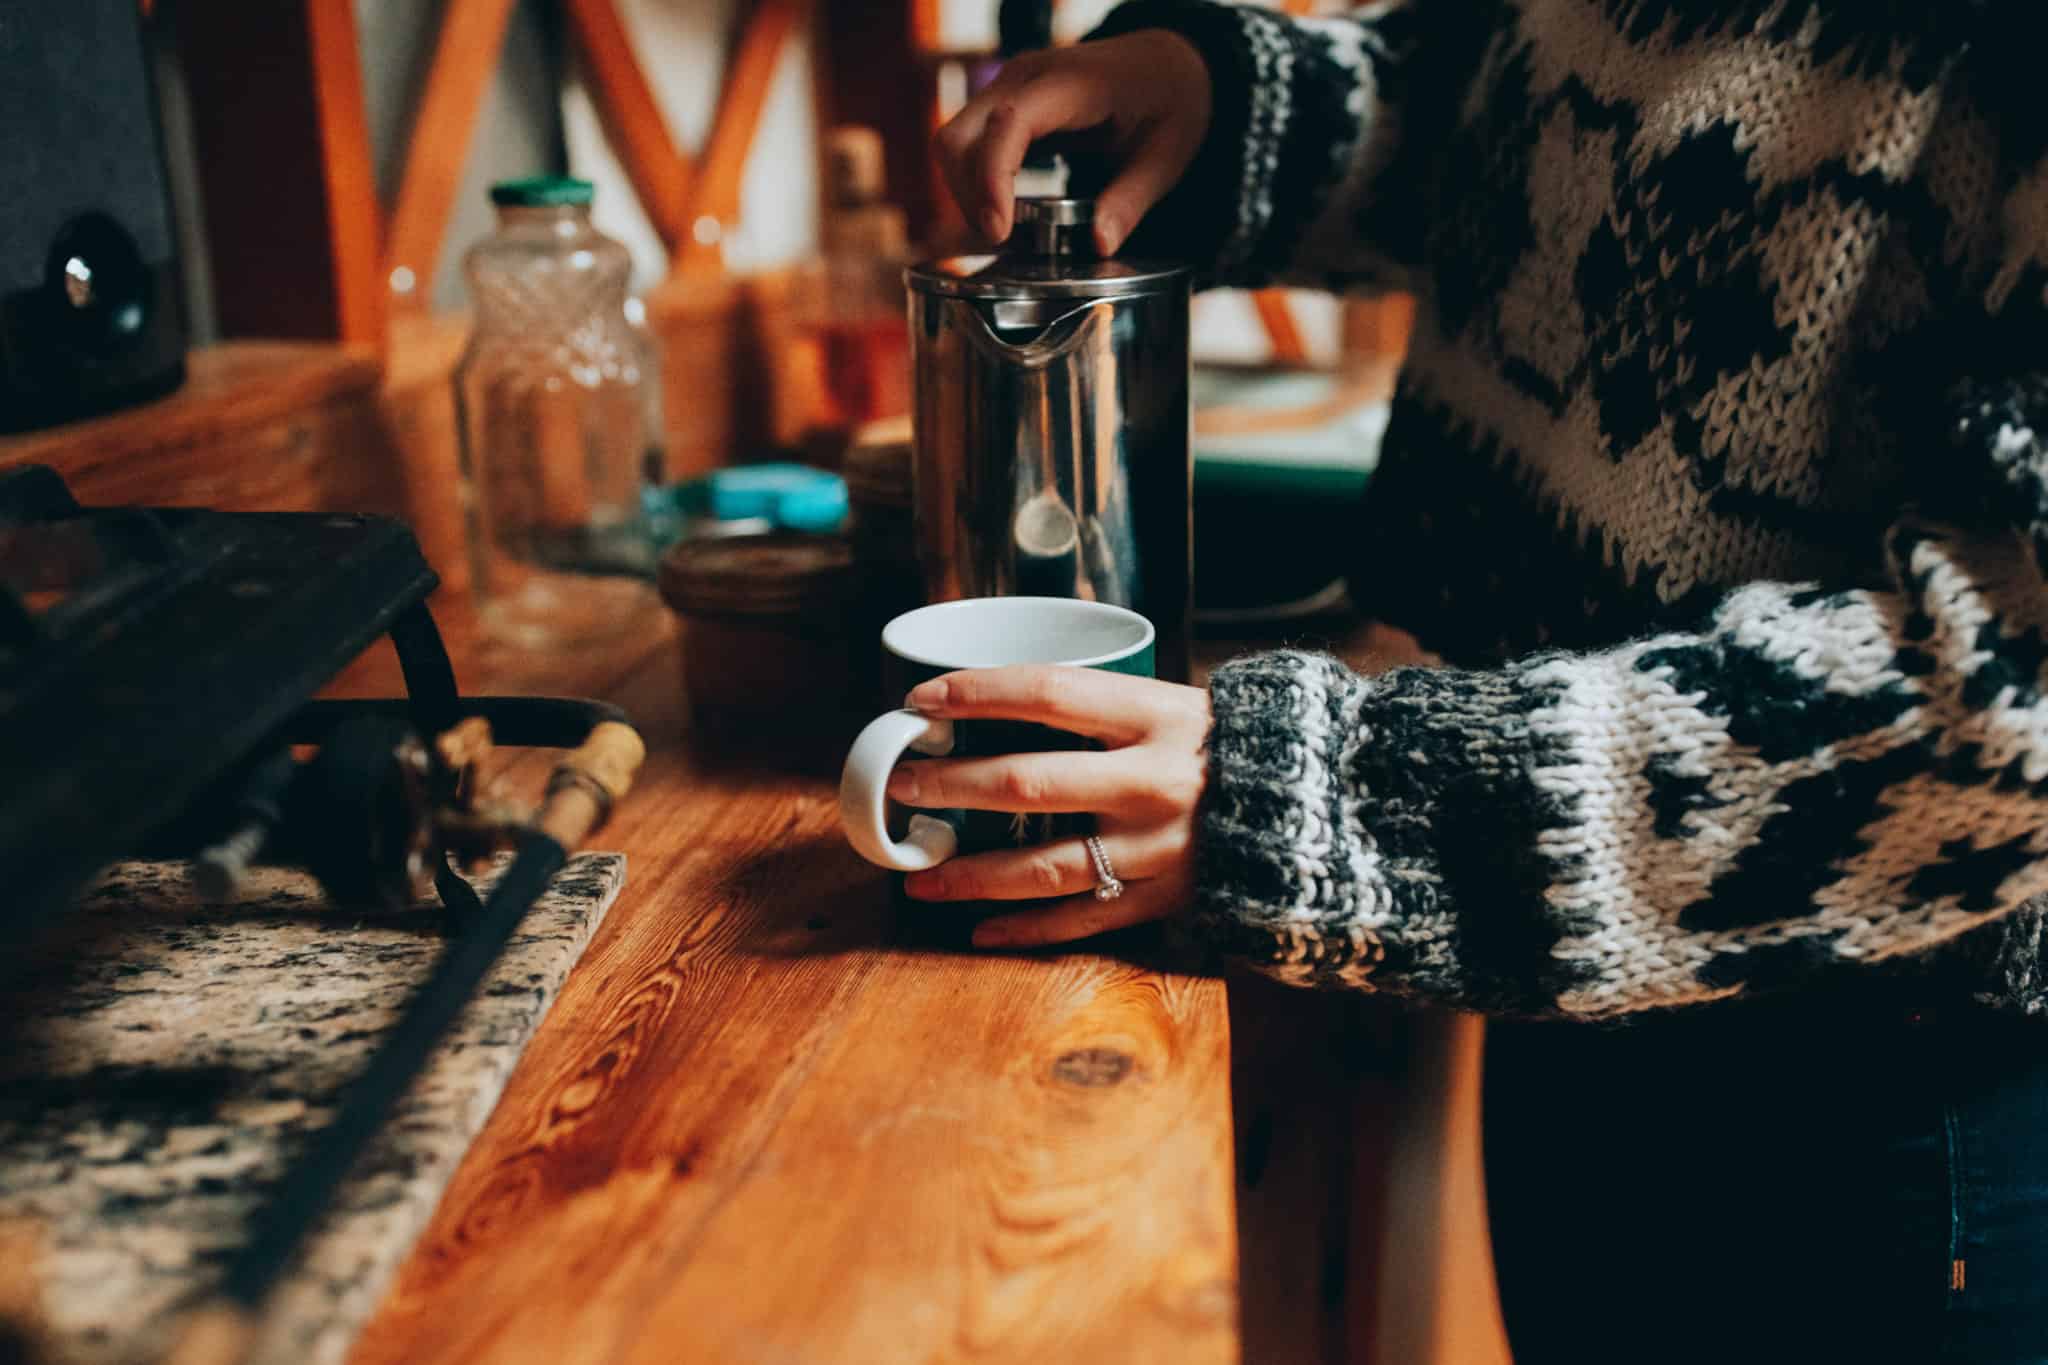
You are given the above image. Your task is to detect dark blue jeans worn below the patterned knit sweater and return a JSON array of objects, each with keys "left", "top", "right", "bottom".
[{"left": 1485, "top": 986, "right": 2048, "bottom": 1365}]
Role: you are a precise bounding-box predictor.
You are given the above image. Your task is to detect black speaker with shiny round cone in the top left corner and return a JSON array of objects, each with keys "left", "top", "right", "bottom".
[{"left": 0, "top": 0, "right": 184, "bottom": 432}]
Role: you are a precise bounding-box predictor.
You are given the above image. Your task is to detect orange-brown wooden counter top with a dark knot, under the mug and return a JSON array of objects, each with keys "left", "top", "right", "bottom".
[{"left": 338, "top": 608, "right": 1425, "bottom": 1365}]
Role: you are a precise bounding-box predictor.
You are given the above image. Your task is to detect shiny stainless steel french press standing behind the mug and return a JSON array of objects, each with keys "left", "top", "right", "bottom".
[{"left": 907, "top": 199, "right": 1194, "bottom": 681}]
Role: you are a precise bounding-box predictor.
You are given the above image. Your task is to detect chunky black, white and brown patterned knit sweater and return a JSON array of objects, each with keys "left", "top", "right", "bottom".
[{"left": 1106, "top": 0, "right": 2048, "bottom": 1017}]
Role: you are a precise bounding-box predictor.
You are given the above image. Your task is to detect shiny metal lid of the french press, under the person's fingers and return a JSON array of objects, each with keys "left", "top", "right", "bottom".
[{"left": 903, "top": 199, "right": 1188, "bottom": 299}]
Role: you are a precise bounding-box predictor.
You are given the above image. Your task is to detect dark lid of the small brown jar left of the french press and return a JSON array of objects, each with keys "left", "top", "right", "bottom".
[{"left": 659, "top": 532, "right": 860, "bottom": 618}]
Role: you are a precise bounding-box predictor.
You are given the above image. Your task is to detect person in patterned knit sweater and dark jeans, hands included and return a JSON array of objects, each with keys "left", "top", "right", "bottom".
[{"left": 891, "top": 0, "right": 2048, "bottom": 1361}]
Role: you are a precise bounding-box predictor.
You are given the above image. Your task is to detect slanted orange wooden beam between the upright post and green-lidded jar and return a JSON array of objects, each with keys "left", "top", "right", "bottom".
[{"left": 382, "top": 0, "right": 514, "bottom": 307}]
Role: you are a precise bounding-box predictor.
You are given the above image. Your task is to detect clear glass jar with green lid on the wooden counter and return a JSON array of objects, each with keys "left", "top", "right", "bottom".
[{"left": 455, "top": 178, "right": 662, "bottom": 647}]
